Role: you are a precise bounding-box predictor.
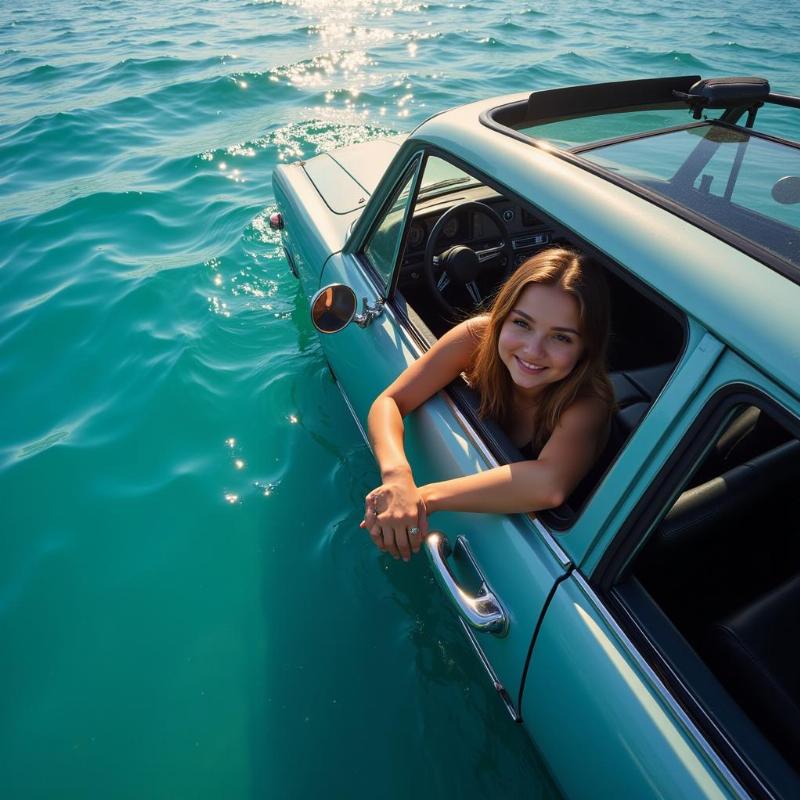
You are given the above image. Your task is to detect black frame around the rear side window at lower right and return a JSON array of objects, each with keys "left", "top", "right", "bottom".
[{"left": 589, "top": 382, "right": 800, "bottom": 797}]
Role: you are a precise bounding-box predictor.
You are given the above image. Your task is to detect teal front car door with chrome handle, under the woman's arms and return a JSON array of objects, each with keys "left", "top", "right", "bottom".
[{"left": 321, "top": 148, "right": 569, "bottom": 718}]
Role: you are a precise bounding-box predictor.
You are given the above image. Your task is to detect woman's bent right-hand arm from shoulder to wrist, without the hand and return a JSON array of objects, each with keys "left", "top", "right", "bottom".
[{"left": 420, "top": 400, "right": 607, "bottom": 514}]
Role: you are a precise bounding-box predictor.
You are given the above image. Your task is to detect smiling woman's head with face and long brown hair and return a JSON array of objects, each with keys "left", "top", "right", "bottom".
[{"left": 470, "top": 248, "right": 613, "bottom": 452}]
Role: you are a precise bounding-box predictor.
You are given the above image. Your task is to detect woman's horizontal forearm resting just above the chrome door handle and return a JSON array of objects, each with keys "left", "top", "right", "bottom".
[{"left": 420, "top": 461, "right": 571, "bottom": 514}]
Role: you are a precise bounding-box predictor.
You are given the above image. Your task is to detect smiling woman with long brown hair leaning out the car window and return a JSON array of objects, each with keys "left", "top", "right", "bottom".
[{"left": 361, "top": 247, "right": 614, "bottom": 561}]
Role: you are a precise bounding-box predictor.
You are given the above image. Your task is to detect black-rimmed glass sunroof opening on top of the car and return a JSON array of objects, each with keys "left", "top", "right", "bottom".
[{"left": 481, "top": 75, "right": 800, "bottom": 283}]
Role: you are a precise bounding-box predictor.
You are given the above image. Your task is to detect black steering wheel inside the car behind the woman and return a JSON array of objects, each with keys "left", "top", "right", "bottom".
[{"left": 422, "top": 200, "right": 514, "bottom": 316}]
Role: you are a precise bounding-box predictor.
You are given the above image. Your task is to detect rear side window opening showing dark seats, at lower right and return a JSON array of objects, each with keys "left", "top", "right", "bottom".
[{"left": 612, "top": 398, "right": 800, "bottom": 794}]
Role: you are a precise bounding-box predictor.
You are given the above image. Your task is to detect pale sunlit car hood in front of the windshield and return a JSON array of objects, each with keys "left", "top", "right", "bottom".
[{"left": 303, "top": 135, "right": 406, "bottom": 214}]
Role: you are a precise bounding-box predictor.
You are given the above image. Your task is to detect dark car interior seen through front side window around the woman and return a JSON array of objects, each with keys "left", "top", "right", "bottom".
[{"left": 395, "top": 159, "right": 685, "bottom": 529}]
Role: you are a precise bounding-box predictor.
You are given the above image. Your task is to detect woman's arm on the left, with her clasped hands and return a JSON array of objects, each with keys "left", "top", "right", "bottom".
[{"left": 362, "top": 318, "right": 485, "bottom": 560}]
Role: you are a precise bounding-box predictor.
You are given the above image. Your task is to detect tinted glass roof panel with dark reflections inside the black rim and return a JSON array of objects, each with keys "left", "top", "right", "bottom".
[{"left": 581, "top": 124, "right": 800, "bottom": 266}]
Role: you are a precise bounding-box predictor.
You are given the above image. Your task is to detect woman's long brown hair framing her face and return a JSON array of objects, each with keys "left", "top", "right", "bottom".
[{"left": 467, "top": 247, "right": 614, "bottom": 448}]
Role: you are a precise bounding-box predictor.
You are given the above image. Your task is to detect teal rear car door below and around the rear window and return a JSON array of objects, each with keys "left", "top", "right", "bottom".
[{"left": 522, "top": 334, "right": 780, "bottom": 798}]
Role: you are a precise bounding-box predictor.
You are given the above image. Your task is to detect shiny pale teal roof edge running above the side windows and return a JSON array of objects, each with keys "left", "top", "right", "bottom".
[{"left": 405, "top": 93, "right": 800, "bottom": 395}]
